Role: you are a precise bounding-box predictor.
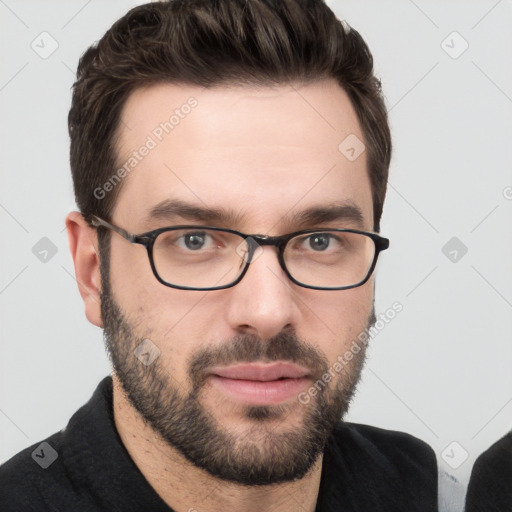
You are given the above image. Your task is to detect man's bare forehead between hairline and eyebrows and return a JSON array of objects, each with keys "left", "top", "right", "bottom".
[{"left": 114, "top": 80, "right": 373, "bottom": 232}]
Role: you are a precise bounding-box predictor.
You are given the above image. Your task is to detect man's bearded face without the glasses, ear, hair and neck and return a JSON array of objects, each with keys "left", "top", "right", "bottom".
[{"left": 102, "top": 80, "right": 374, "bottom": 485}]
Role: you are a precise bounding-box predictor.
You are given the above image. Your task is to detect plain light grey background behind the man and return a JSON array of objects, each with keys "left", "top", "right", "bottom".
[{"left": 0, "top": 0, "right": 512, "bottom": 504}]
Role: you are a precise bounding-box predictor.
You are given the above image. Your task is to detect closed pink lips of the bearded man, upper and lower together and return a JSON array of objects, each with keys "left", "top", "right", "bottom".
[{"left": 209, "top": 363, "right": 310, "bottom": 405}]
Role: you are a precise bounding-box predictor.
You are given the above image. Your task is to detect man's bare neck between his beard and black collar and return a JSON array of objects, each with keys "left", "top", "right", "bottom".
[{"left": 113, "top": 374, "right": 322, "bottom": 512}]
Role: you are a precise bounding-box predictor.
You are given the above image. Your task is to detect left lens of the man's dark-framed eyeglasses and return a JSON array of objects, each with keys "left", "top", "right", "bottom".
[{"left": 153, "top": 228, "right": 249, "bottom": 288}]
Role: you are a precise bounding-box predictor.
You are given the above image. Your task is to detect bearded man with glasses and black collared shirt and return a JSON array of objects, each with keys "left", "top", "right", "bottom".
[{"left": 0, "top": 0, "right": 437, "bottom": 512}]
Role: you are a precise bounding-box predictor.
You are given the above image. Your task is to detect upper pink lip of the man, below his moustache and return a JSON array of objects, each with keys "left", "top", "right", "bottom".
[{"left": 211, "top": 363, "right": 308, "bottom": 382}]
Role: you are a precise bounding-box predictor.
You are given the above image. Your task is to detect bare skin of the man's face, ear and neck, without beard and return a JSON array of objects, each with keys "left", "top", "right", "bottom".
[{"left": 67, "top": 79, "right": 374, "bottom": 512}]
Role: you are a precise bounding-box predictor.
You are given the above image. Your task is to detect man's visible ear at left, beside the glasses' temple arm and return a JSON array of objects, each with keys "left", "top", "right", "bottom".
[{"left": 66, "top": 212, "right": 103, "bottom": 327}]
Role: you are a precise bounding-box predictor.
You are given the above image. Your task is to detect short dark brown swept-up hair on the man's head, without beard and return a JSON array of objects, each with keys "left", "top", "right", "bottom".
[{"left": 68, "top": 0, "right": 391, "bottom": 232}]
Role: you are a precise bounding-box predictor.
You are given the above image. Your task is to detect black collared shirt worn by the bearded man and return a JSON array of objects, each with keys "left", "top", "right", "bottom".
[{"left": 0, "top": 377, "right": 437, "bottom": 512}]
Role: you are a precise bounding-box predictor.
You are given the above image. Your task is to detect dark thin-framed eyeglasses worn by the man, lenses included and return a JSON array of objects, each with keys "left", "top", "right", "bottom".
[{"left": 92, "top": 216, "right": 389, "bottom": 291}]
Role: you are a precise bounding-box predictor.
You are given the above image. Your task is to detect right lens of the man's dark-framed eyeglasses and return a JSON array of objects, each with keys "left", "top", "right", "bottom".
[{"left": 284, "top": 231, "right": 375, "bottom": 288}]
